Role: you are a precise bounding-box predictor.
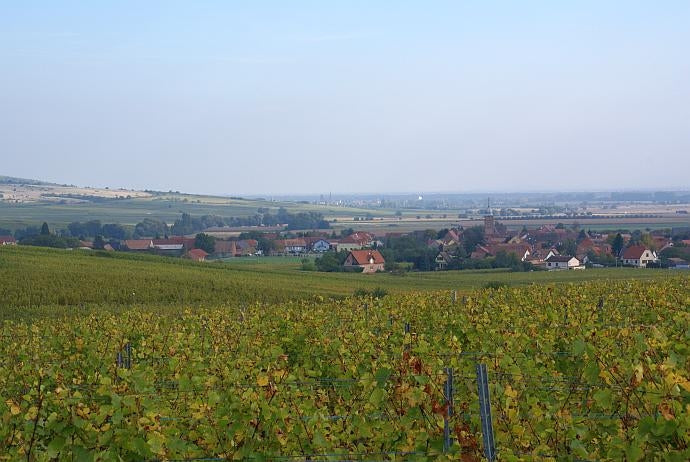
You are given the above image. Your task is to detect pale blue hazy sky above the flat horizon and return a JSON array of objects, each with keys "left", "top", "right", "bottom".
[{"left": 0, "top": 0, "right": 690, "bottom": 194}]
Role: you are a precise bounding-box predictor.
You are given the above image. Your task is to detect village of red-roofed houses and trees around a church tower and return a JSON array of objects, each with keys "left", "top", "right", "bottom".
[{"left": 0, "top": 208, "right": 690, "bottom": 273}]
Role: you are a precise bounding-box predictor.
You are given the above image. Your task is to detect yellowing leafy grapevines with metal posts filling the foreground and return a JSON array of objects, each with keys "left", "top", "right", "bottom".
[{"left": 0, "top": 277, "right": 690, "bottom": 461}]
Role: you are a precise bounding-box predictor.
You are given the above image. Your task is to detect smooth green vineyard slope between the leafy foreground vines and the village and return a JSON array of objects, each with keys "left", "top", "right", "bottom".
[{"left": 0, "top": 246, "right": 675, "bottom": 318}]
